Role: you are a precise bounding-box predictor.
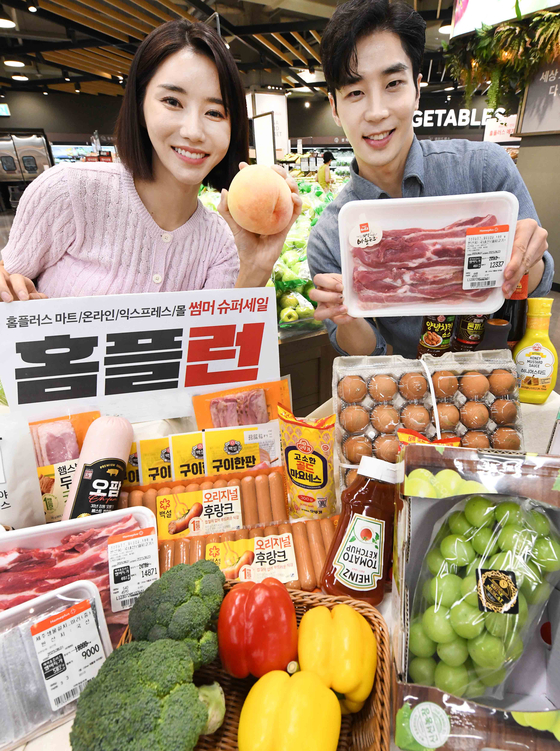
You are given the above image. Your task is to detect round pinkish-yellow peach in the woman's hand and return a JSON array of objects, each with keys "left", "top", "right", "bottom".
[{"left": 228, "top": 164, "right": 293, "bottom": 235}]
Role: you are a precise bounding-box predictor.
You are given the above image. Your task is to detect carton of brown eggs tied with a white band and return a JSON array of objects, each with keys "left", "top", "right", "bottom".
[{"left": 333, "top": 350, "right": 522, "bottom": 496}]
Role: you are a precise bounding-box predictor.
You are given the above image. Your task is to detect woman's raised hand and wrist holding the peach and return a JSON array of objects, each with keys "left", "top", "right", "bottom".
[{"left": 218, "top": 162, "right": 302, "bottom": 287}]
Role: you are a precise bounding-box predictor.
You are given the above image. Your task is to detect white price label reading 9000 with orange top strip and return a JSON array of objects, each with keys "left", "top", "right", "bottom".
[{"left": 31, "top": 600, "right": 105, "bottom": 712}]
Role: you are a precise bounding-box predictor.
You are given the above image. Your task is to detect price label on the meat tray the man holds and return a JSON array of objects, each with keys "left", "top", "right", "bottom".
[{"left": 463, "top": 224, "right": 509, "bottom": 289}]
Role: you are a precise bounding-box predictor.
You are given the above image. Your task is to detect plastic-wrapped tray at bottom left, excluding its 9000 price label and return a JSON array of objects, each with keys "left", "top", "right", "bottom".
[{"left": 0, "top": 581, "right": 112, "bottom": 751}]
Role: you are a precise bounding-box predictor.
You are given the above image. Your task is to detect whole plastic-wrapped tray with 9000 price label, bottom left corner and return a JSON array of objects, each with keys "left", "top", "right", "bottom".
[{"left": 0, "top": 581, "right": 112, "bottom": 751}]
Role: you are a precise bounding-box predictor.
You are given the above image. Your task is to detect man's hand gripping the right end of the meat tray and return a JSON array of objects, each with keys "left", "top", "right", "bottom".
[{"left": 502, "top": 219, "right": 548, "bottom": 298}]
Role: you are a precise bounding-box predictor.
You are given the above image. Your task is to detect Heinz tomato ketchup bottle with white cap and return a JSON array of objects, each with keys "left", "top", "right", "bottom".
[{"left": 321, "top": 456, "right": 397, "bottom": 606}]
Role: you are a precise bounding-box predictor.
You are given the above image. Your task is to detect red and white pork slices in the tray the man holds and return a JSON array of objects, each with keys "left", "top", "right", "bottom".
[{"left": 352, "top": 214, "right": 497, "bottom": 307}]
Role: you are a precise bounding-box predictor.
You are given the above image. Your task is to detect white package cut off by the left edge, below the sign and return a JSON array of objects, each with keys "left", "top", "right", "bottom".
[{"left": 0, "top": 414, "right": 45, "bottom": 529}]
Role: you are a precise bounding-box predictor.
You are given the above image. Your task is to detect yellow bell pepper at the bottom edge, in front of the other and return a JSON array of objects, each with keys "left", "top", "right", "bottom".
[{"left": 237, "top": 670, "right": 341, "bottom": 751}]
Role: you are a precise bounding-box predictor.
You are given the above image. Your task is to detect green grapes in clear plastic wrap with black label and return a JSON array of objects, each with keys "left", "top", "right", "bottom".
[{"left": 408, "top": 495, "right": 560, "bottom": 698}]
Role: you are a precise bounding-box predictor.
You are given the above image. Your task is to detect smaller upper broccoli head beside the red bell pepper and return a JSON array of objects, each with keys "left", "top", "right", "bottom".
[{"left": 128, "top": 560, "right": 225, "bottom": 670}]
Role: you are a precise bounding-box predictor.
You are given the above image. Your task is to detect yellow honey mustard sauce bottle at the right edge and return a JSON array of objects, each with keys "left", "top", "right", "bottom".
[{"left": 513, "top": 297, "right": 558, "bottom": 404}]
